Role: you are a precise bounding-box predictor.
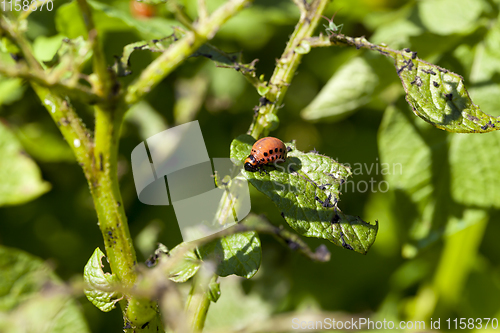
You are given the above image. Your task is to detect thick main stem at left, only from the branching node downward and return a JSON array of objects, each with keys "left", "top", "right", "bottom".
[{"left": 90, "top": 103, "right": 162, "bottom": 332}]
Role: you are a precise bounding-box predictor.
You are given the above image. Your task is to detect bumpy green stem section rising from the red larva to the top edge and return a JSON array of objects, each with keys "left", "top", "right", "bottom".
[{"left": 249, "top": 0, "right": 329, "bottom": 139}]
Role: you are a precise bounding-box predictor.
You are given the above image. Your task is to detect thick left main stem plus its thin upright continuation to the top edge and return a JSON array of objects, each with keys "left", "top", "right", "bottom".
[{"left": 70, "top": 0, "right": 156, "bottom": 326}]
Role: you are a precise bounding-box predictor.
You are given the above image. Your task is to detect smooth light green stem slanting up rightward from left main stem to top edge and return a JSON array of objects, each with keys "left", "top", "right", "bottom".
[{"left": 125, "top": 0, "right": 251, "bottom": 104}]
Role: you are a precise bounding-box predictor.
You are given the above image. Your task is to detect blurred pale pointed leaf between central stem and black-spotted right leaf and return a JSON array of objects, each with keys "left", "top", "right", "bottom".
[{"left": 301, "top": 57, "right": 378, "bottom": 121}]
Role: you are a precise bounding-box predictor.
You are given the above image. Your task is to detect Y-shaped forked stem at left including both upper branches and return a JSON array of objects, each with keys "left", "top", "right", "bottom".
[{"left": 0, "top": 9, "right": 158, "bottom": 332}]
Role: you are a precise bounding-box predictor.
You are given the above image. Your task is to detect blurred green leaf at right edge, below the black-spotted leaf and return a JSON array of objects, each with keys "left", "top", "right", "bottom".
[{"left": 449, "top": 132, "right": 500, "bottom": 208}]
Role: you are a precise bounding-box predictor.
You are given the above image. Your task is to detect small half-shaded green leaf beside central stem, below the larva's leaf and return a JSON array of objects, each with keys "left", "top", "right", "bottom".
[{"left": 198, "top": 231, "right": 262, "bottom": 279}]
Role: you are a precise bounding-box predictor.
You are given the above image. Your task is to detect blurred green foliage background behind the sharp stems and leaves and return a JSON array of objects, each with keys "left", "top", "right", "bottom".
[{"left": 0, "top": 0, "right": 500, "bottom": 332}]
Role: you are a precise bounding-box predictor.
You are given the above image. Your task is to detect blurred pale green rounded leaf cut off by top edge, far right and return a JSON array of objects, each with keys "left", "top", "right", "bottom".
[{"left": 417, "top": 0, "right": 485, "bottom": 35}]
